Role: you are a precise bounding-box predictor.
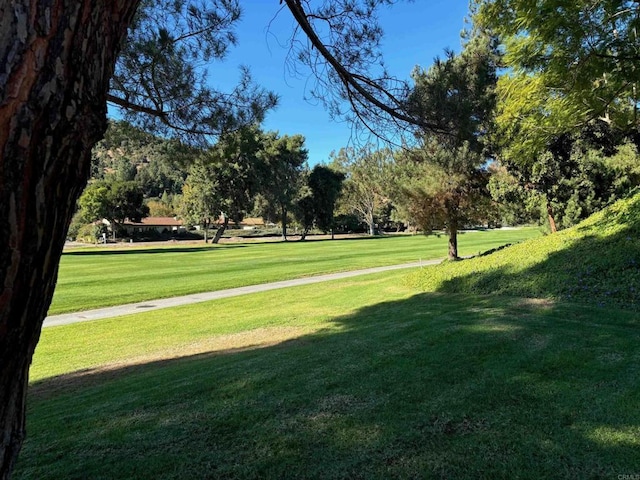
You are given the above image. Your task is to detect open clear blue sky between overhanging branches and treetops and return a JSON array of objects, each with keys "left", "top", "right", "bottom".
[{"left": 218, "top": 0, "right": 468, "bottom": 166}]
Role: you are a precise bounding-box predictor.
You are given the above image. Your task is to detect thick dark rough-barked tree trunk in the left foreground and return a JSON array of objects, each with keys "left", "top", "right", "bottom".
[{"left": 0, "top": 0, "right": 138, "bottom": 479}]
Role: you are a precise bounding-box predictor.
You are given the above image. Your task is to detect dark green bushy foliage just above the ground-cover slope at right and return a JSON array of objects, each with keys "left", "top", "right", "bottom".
[{"left": 490, "top": 122, "right": 640, "bottom": 231}]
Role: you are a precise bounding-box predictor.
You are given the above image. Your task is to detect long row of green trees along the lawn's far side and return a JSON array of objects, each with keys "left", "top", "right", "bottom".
[{"left": 80, "top": 16, "right": 640, "bottom": 259}]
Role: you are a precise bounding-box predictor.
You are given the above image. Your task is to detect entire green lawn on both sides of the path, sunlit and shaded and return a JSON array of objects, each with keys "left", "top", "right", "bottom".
[{"left": 21, "top": 196, "right": 640, "bottom": 479}]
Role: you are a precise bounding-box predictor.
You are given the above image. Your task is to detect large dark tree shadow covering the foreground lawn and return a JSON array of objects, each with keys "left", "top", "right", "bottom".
[{"left": 15, "top": 294, "right": 640, "bottom": 479}]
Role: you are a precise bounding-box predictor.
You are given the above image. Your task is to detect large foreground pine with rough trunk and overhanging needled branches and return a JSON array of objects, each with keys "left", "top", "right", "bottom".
[{"left": 0, "top": 0, "right": 440, "bottom": 478}]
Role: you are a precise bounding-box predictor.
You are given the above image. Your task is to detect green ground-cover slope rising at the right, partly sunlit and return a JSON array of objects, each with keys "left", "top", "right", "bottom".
[{"left": 409, "top": 189, "right": 640, "bottom": 310}]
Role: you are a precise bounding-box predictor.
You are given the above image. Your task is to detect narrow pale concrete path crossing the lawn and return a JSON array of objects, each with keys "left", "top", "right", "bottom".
[{"left": 43, "top": 259, "right": 442, "bottom": 327}]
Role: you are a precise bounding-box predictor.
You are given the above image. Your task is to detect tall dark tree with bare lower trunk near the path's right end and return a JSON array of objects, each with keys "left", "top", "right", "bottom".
[{"left": 406, "top": 35, "right": 498, "bottom": 259}]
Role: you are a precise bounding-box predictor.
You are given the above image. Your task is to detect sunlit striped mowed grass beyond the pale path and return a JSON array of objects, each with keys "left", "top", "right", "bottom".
[{"left": 49, "top": 228, "right": 540, "bottom": 315}]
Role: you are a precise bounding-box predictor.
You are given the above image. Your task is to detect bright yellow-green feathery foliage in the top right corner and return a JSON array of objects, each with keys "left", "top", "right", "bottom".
[{"left": 474, "top": 0, "right": 640, "bottom": 154}]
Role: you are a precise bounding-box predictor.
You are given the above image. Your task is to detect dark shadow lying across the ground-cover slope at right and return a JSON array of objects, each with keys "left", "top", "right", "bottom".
[{"left": 427, "top": 219, "right": 640, "bottom": 310}]
